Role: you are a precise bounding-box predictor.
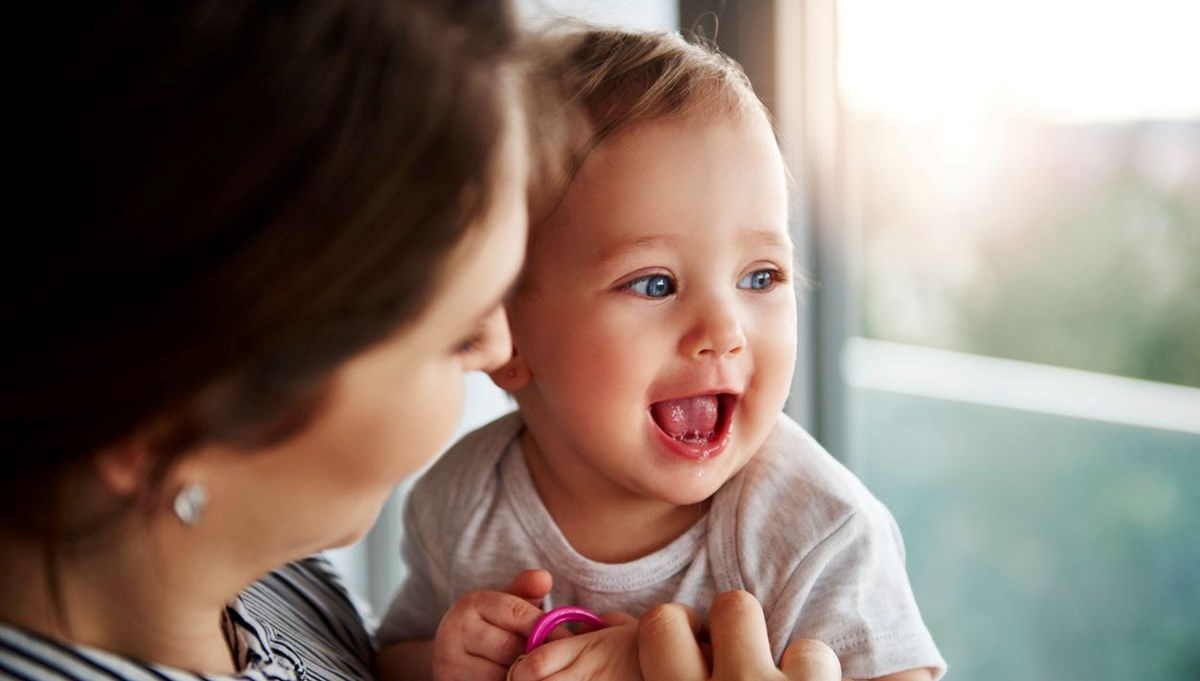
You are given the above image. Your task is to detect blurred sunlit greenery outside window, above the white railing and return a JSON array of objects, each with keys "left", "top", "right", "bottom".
[{"left": 851, "top": 117, "right": 1200, "bottom": 387}]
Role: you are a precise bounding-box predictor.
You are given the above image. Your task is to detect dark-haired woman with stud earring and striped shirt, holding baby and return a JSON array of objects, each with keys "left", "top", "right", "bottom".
[{"left": 0, "top": 0, "right": 840, "bottom": 680}]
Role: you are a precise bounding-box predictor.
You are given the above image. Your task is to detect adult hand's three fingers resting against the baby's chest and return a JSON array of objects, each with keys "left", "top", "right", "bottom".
[{"left": 637, "top": 591, "right": 841, "bottom": 681}]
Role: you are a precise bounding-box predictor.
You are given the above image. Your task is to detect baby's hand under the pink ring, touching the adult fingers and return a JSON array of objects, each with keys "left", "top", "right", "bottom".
[{"left": 509, "top": 613, "right": 642, "bottom": 681}]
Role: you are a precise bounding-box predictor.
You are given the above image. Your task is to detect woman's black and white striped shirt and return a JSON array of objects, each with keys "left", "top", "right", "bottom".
[{"left": 0, "top": 556, "right": 376, "bottom": 681}]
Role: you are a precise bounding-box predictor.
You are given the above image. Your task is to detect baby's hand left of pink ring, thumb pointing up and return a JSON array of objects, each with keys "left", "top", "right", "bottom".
[{"left": 432, "top": 571, "right": 550, "bottom": 681}]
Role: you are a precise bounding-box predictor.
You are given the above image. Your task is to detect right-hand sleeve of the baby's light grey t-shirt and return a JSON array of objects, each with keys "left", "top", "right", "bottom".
[{"left": 772, "top": 498, "right": 946, "bottom": 679}]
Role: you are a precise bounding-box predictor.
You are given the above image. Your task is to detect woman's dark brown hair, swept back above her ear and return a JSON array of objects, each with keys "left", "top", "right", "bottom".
[{"left": 0, "top": 0, "right": 516, "bottom": 537}]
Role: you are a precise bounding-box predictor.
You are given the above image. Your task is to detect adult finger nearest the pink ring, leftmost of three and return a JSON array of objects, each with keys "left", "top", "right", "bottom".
[{"left": 637, "top": 603, "right": 708, "bottom": 681}]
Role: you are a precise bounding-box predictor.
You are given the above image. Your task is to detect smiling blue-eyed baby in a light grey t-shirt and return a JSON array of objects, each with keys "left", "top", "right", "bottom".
[{"left": 380, "top": 30, "right": 946, "bottom": 680}]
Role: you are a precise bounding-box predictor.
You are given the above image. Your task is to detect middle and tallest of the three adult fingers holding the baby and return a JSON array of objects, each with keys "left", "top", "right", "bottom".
[{"left": 708, "top": 591, "right": 777, "bottom": 681}]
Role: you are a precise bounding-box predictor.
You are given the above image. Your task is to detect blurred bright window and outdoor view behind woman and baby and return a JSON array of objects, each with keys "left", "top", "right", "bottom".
[{"left": 337, "top": 0, "right": 1200, "bottom": 681}]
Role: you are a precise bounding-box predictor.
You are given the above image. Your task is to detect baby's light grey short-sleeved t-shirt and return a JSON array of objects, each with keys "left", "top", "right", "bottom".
[{"left": 379, "top": 414, "right": 946, "bottom": 679}]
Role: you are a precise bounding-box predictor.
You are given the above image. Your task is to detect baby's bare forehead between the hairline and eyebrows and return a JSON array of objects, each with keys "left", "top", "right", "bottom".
[{"left": 529, "top": 112, "right": 787, "bottom": 260}]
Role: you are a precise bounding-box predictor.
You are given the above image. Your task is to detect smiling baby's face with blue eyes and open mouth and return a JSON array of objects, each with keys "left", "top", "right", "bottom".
[{"left": 510, "top": 113, "right": 796, "bottom": 505}]
